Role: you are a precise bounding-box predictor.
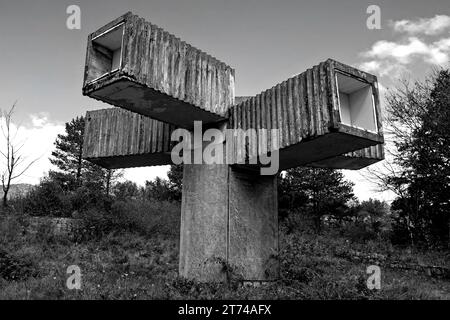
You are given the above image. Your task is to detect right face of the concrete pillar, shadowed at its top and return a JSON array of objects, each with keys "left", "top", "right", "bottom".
[{"left": 228, "top": 167, "right": 278, "bottom": 280}]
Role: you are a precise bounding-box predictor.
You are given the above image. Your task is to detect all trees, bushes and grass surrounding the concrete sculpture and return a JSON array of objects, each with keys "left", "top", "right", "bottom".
[{"left": 0, "top": 71, "right": 450, "bottom": 299}]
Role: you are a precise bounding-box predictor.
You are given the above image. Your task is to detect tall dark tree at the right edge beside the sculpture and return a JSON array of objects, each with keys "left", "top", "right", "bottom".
[{"left": 373, "top": 70, "right": 450, "bottom": 248}]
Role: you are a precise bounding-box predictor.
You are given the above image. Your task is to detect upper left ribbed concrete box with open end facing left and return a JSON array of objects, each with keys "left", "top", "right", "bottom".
[{"left": 83, "top": 13, "right": 234, "bottom": 128}]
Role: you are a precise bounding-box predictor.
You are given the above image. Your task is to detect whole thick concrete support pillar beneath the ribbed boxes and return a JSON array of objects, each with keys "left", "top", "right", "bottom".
[{"left": 180, "top": 165, "right": 279, "bottom": 281}]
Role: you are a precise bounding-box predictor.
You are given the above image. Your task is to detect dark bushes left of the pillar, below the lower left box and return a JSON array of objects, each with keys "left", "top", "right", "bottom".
[{"left": 20, "top": 174, "right": 180, "bottom": 240}]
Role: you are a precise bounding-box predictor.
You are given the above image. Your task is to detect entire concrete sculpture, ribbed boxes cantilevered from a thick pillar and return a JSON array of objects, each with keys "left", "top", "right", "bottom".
[{"left": 83, "top": 13, "right": 384, "bottom": 281}]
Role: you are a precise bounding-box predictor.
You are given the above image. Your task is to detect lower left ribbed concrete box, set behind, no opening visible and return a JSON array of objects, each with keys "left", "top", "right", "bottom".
[{"left": 83, "top": 108, "right": 175, "bottom": 169}]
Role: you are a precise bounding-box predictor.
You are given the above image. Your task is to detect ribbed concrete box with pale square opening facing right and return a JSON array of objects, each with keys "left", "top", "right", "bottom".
[{"left": 227, "top": 59, "right": 384, "bottom": 170}]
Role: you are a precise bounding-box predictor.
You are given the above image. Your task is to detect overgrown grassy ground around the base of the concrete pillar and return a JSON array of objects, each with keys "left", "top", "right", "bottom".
[{"left": 0, "top": 208, "right": 450, "bottom": 300}]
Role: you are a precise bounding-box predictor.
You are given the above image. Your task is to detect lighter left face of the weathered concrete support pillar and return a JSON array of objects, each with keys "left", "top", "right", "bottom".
[{"left": 180, "top": 165, "right": 228, "bottom": 281}]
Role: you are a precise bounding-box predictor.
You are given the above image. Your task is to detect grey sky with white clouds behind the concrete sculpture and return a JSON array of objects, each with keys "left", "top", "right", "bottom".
[{"left": 0, "top": 0, "right": 450, "bottom": 200}]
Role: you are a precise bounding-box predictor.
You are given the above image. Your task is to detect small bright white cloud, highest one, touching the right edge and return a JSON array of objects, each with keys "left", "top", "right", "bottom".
[{"left": 391, "top": 15, "right": 450, "bottom": 35}]
